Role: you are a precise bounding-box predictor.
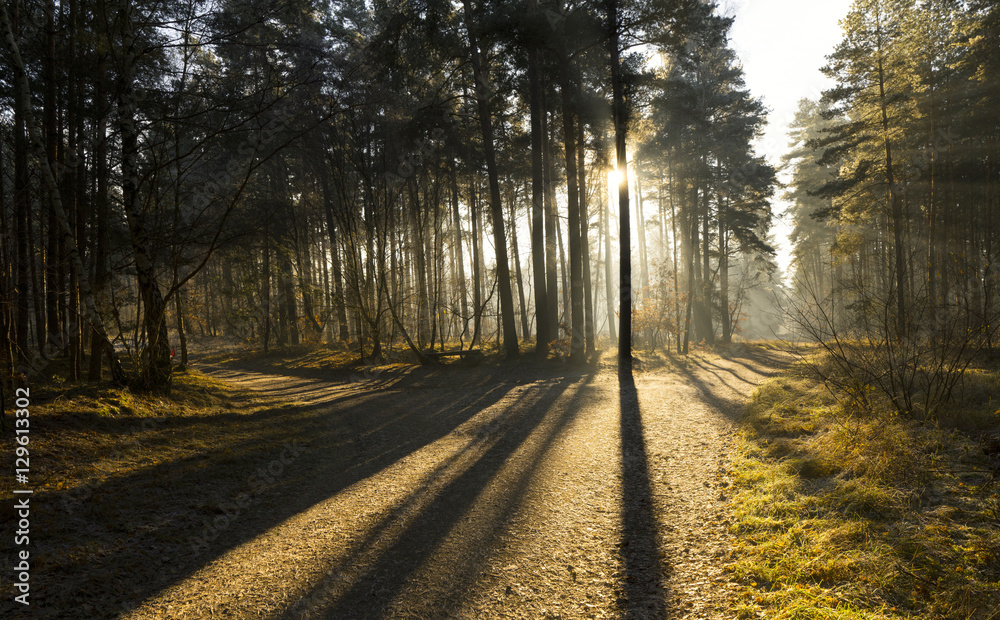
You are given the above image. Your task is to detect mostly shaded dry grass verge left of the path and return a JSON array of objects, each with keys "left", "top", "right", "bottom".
[{"left": 0, "top": 371, "right": 301, "bottom": 618}]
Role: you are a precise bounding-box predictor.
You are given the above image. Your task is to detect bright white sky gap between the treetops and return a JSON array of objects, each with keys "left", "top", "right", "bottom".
[{"left": 722, "top": 0, "right": 851, "bottom": 274}]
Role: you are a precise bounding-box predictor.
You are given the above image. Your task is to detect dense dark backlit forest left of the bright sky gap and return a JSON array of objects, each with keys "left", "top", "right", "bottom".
[{"left": 2, "top": 2, "right": 777, "bottom": 389}]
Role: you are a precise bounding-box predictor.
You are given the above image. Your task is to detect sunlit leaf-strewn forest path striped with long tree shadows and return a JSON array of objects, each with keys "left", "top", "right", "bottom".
[{"left": 123, "top": 348, "right": 787, "bottom": 620}]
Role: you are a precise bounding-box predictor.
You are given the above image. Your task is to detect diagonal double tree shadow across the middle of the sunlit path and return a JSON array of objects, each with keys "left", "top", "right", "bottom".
[{"left": 277, "top": 370, "right": 589, "bottom": 620}]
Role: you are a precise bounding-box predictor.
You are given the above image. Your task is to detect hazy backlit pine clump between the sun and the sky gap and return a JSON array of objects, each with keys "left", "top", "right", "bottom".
[{"left": 637, "top": 7, "right": 776, "bottom": 352}]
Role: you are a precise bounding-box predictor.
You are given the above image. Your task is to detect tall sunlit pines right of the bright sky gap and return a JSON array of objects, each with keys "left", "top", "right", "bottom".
[{"left": 789, "top": 0, "right": 1000, "bottom": 416}]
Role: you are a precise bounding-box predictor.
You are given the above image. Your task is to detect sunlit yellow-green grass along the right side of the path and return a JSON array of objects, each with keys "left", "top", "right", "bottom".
[{"left": 727, "top": 354, "right": 1000, "bottom": 620}]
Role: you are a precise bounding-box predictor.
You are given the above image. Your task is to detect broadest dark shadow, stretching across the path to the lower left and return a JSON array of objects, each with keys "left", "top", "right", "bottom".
[{"left": 5, "top": 370, "right": 580, "bottom": 619}]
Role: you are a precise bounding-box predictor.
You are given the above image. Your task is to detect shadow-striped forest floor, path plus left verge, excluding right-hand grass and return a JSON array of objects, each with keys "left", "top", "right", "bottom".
[{"left": 0, "top": 346, "right": 791, "bottom": 620}]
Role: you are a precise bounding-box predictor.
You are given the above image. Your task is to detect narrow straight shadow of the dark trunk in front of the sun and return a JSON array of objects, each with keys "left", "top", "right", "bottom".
[{"left": 618, "top": 366, "right": 667, "bottom": 619}]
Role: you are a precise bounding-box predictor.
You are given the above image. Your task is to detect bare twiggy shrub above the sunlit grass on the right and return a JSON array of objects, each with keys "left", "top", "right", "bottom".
[{"left": 785, "top": 266, "right": 997, "bottom": 420}]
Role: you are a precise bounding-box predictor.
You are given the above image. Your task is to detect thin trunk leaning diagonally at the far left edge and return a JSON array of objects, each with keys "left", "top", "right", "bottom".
[{"left": 0, "top": 5, "right": 126, "bottom": 385}]
